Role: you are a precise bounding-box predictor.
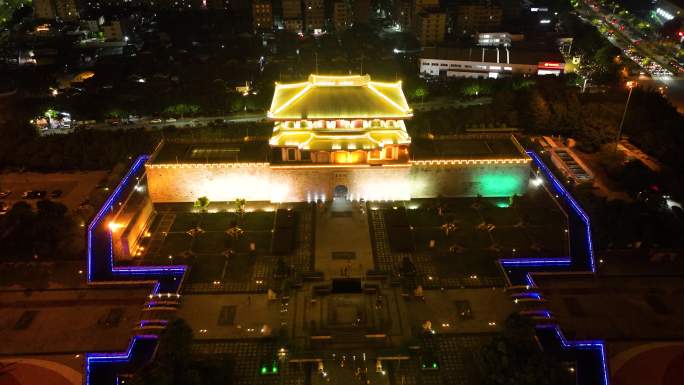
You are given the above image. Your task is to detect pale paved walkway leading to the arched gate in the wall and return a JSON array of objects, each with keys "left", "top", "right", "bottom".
[{"left": 314, "top": 199, "right": 373, "bottom": 279}]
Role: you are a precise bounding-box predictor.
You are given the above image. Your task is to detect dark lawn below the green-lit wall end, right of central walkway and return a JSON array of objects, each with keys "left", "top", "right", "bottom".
[{"left": 406, "top": 191, "right": 567, "bottom": 277}]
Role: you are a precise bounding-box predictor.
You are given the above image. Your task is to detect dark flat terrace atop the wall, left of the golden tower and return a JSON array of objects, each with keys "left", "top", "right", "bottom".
[{"left": 150, "top": 141, "right": 270, "bottom": 164}]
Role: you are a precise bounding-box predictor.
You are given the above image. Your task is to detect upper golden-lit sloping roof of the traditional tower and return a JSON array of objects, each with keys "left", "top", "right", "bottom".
[{"left": 268, "top": 75, "right": 412, "bottom": 120}]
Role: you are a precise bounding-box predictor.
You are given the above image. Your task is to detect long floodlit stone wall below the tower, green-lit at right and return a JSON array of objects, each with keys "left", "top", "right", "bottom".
[{"left": 147, "top": 162, "right": 529, "bottom": 202}]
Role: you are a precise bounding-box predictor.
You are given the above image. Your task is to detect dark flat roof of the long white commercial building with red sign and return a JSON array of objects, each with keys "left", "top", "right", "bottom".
[{"left": 420, "top": 47, "right": 564, "bottom": 65}]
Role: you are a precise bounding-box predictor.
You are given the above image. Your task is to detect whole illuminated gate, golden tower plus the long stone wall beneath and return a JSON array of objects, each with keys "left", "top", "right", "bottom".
[{"left": 146, "top": 75, "right": 530, "bottom": 202}]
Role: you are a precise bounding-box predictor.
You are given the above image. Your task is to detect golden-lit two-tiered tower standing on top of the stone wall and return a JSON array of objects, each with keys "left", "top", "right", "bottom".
[{"left": 268, "top": 75, "right": 413, "bottom": 165}]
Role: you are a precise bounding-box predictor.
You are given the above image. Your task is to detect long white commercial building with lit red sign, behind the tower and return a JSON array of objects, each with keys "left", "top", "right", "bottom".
[{"left": 420, "top": 47, "right": 565, "bottom": 78}]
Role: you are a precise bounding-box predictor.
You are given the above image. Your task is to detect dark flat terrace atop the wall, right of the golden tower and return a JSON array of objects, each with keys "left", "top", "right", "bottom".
[{"left": 410, "top": 134, "right": 527, "bottom": 160}]
